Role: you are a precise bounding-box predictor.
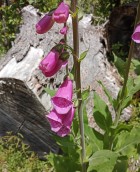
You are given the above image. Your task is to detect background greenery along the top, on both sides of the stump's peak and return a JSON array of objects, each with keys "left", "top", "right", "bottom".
[{"left": 0, "top": 0, "right": 136, "bottom": 56}]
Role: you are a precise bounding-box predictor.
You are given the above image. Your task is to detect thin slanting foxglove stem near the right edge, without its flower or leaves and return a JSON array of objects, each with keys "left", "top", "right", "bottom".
[{"left": 114, "top": 0, "right": 140, "bottom": 126}]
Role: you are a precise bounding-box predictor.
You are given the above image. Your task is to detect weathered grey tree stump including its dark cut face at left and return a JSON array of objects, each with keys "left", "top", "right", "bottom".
[{"left": 0, "top": 6, "right": 126, "bottom": 152}]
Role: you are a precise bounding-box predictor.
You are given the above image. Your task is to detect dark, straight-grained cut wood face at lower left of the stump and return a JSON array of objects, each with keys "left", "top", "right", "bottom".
[{"left": 0, "top": 78, "right": 58, "bottom": 152}]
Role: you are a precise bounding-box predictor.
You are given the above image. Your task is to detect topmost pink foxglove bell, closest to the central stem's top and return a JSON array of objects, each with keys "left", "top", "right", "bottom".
[{"left": 53, "top": 2, "right": 69, "bottom": 23}]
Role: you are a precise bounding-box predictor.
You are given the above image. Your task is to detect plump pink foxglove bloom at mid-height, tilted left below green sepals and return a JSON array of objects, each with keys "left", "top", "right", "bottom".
[{"left": 39, "top": 49, "right": 68, "bottom": 77}]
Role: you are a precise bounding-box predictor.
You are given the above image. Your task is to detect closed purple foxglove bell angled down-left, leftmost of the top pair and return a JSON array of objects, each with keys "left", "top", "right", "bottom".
[{"left": 36, "top": 14, "right": 54, "bottom": 34}]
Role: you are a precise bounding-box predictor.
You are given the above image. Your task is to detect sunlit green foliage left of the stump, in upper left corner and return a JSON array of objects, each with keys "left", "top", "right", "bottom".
[{"left": 0, "top": 0, "right": 60, "bottom": 56}]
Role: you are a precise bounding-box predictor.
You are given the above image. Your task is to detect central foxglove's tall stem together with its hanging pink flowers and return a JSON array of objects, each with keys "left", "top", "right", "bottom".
[{"left": 36, "top": 0, "right": 85, "bottom": 171}]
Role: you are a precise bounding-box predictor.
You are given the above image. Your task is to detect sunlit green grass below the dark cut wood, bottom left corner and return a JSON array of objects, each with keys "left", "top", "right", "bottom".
[{"left": 0, "top": 133, "right": 50, "bottom": 172}]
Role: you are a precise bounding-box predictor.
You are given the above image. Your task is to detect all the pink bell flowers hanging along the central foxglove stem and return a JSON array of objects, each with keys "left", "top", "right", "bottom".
[{"left": 36, "top": 2, "right": 75, "bottom": 137}]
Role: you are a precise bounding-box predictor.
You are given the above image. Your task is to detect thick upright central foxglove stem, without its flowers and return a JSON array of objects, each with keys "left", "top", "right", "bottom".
[{"left": 71, "top": 0, "right": 86, "bottom": 172}]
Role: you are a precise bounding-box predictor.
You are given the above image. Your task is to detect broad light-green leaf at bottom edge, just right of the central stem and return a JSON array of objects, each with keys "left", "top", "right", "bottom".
[{"left": 87, "top": 150, "right": 118, "bottom": 172}]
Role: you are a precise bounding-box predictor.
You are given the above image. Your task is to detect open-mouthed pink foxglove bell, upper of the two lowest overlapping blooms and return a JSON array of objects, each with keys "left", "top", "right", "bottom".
[{"left": 51, "top": 77, "right": 73, "bottom": 114}]
